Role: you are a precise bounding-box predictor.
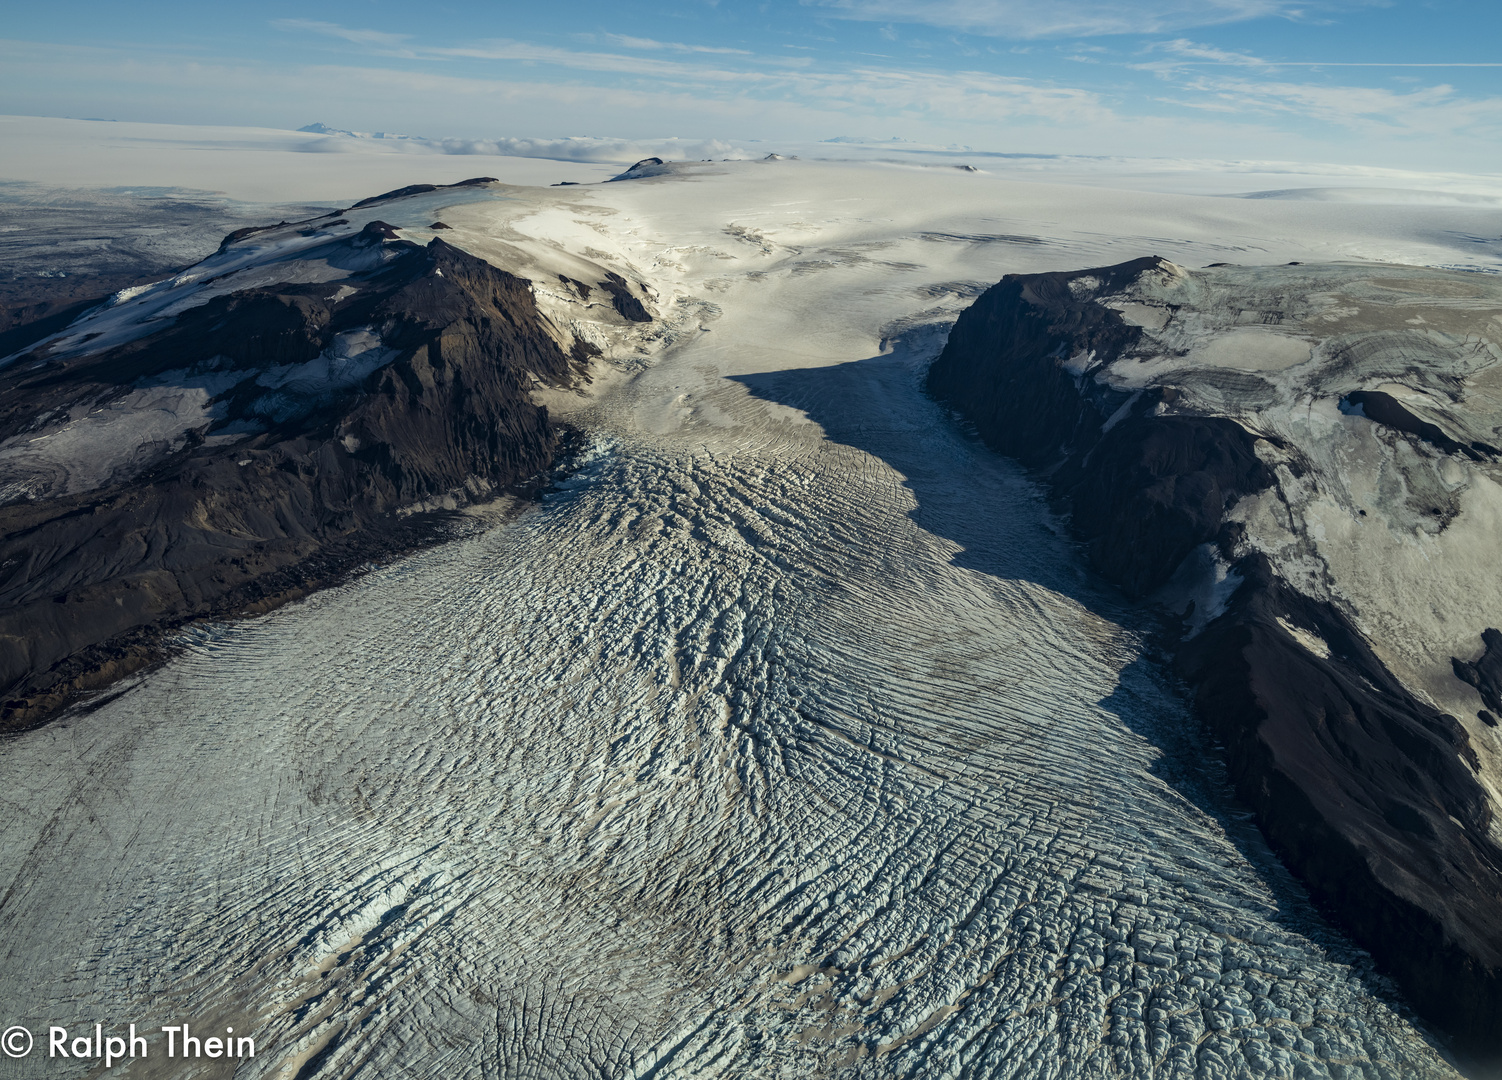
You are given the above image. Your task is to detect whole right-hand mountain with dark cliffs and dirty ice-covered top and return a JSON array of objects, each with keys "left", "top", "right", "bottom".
[{"left": 928, "top": 258, "right": 1502, "bottom": 1063}]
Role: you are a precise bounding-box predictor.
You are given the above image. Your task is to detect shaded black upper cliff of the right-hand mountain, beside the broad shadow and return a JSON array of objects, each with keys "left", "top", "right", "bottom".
[{"left": 928, "top": 258, "right": 1272, "bottom": 596}]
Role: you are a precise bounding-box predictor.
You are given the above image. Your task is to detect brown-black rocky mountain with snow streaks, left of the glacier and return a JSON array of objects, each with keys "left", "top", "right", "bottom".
[{"left": 0, "top": 216, "right": 593, "bottom": 727}]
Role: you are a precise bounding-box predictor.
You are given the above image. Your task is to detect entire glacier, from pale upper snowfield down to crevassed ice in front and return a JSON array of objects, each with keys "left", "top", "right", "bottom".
[{"left": 0, "top": 139, "right": 1497, "bottom": 1080}]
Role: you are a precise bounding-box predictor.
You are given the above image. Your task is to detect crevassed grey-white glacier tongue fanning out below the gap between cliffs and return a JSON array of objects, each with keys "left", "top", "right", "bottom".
[{"left": 5, "top": 374, "right": 1440, "bottom": 1077}]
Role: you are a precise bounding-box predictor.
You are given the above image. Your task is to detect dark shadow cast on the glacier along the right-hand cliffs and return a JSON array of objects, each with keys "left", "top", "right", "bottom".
[{"left": 730, "top": 327, "right": 1392, "bottom": 961}]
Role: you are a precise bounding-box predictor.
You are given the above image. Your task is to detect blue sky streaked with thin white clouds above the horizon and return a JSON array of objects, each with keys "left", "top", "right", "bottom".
[{"left": 0, "top": 0, "right": 1502, "bottom": 173}]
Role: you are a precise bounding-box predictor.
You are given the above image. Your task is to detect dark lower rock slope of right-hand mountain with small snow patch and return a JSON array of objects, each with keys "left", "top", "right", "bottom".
[{"left": 1179, "top": 554, "right": 1502, "bottom": 1062}]
